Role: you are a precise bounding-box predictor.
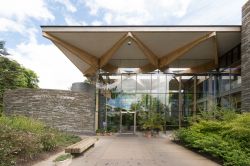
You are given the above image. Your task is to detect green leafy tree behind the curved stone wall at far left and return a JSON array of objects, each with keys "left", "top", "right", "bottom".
[{"left": 0, "top": 56, "right": 39, "bottom": 112}]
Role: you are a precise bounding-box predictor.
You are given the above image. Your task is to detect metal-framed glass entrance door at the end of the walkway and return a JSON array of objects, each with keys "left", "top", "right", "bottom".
[{"left": 120, "top": 111, "right": 136, "bottom": 134}]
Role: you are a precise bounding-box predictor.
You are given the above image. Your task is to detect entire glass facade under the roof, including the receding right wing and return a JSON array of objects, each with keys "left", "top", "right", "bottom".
[{"left": 97, "top": 45, "right": 241, "bottom": 130}]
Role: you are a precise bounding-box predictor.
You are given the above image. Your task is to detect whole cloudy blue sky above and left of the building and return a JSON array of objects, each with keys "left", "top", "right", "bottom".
[{"left": 0, "top": 0, "right": 247, "bottom": 90}]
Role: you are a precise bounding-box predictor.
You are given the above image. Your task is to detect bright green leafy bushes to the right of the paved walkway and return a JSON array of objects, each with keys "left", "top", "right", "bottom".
[{"left": 175, "top": 109, "right": 250, "bottom": 166}]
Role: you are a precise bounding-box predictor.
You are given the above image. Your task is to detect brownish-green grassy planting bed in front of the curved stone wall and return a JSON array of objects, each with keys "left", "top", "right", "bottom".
[{"left": 0, "top": 115, "right": 81, "bottom": 166}]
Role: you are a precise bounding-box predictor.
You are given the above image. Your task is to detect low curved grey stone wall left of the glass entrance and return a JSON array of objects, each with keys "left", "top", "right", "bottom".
[{"left": 4, "top": 89, "right": 95, "bottom": 134}]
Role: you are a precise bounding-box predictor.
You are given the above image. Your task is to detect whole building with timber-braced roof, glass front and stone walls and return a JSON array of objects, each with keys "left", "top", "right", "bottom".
[{"left": 5, "top": 1, "right": 250, "bottom": 134}]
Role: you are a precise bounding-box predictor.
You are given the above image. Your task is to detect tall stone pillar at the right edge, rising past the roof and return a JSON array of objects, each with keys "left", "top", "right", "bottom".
[{"left": 241, "top": 0, "right": 250, "bottom": 112}]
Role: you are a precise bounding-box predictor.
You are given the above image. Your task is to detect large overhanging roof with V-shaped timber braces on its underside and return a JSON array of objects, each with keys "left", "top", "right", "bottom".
[{"left": 41, "top": 26, "right": 241, "bottom": 76}]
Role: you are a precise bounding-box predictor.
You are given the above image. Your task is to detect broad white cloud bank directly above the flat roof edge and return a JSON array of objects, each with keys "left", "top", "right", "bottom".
[{"left": 81, "top": 0, "right": 247, "bottom": 25}]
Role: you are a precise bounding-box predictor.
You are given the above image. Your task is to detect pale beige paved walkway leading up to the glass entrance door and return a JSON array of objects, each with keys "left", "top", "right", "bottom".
[{"left": 70, "top": 136, "right": 218, "bottom": 166}]
